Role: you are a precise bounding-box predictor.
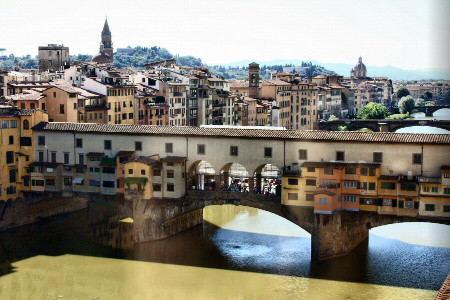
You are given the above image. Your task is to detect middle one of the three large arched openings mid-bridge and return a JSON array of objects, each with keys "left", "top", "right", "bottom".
[{"left": 220, "top": 163, "right": 250, "bottom": 193}]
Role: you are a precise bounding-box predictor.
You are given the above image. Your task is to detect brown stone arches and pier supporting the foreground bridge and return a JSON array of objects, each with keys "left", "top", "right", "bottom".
[{"left": 127, "top": 191, "right": 450, "bottom": 260}]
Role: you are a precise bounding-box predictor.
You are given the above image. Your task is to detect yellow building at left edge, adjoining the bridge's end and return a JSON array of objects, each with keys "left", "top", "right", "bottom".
[{"left": 0, "top": 106, "right": 48, "bottom": 201}]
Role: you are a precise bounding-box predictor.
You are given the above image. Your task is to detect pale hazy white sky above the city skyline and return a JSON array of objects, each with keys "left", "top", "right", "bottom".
[{"left": 0, "top": 0, "right": 450, "bottom": 69}]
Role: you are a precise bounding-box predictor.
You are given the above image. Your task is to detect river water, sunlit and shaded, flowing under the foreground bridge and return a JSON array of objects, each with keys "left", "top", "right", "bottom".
[{"left": 0, "top": 205, "right": 450, "bottom": 299}]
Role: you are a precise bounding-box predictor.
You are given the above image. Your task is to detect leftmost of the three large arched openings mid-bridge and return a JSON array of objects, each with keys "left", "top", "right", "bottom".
[{"left": 188, "top": 160, "right": 216, "bottom": 190}]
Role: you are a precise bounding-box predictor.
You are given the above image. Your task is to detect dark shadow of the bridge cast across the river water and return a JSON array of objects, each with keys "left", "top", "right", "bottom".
[{"left": 0, "top": 203, "right": 450, "bottom": 290}]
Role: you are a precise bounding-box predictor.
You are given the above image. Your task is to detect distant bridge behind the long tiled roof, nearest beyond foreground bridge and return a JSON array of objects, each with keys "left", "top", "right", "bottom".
[{"left": 319, "top": 119, "right": 450, "bottom": 132}]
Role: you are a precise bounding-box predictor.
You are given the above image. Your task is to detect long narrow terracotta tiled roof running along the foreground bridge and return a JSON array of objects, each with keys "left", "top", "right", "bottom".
[{"left": 33, "top": 122, "right": 450, "bottom": 145}]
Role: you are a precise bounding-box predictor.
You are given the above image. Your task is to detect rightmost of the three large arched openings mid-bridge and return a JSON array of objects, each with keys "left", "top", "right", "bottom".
[{"left": 252, "top": 164, "right": 281, "bottom": 195}]
